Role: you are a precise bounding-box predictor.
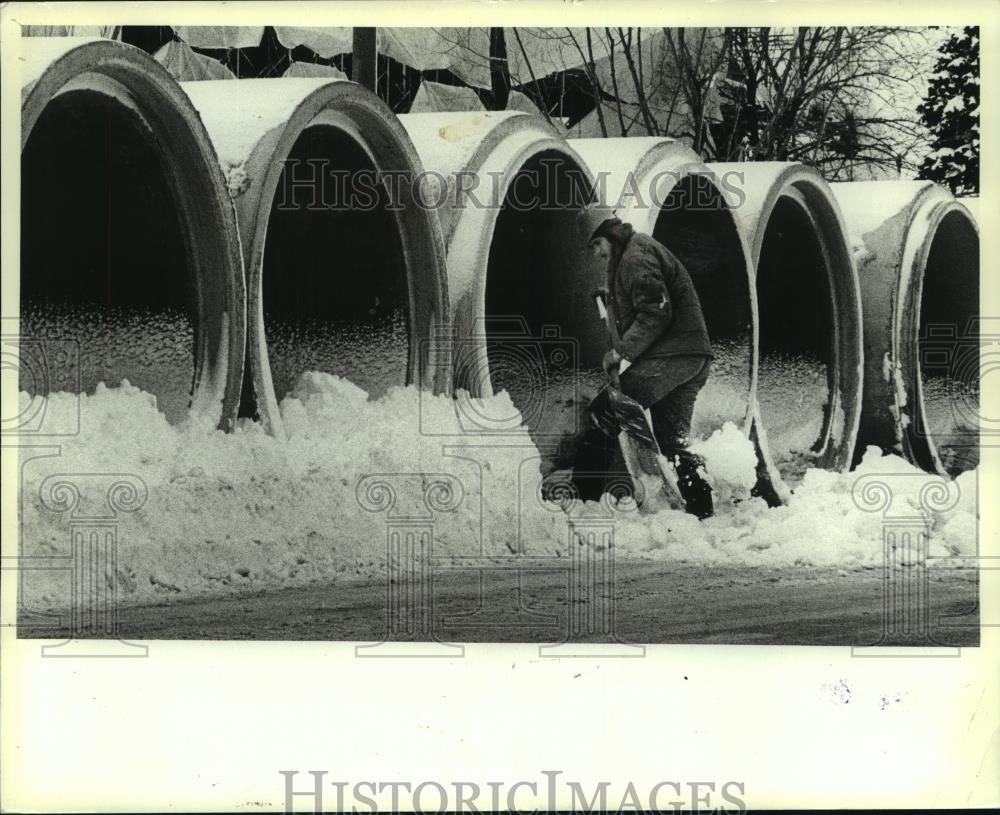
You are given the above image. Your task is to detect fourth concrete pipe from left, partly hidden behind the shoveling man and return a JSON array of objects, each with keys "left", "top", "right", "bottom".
[{"left": 570, "top": 138, "right": 785, "bottom": 504}]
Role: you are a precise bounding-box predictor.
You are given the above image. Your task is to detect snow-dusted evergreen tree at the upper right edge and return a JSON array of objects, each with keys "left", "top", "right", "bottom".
[{"left": 917, "top": 26, "right": 979, "bottom": 195}]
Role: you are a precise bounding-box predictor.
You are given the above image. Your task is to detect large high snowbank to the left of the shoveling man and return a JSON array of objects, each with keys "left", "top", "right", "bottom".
[{"left": 21, "top": 373, "right": 566, "bottom": 603}]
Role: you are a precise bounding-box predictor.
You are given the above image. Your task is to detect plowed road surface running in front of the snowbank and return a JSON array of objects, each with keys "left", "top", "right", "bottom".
[{"left": 18, "top": 561, "right": 979, "bottom": 646}]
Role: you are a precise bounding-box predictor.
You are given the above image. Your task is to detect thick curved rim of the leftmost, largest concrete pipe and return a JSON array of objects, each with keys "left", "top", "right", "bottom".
[{"left": 21, "top": 38, "right": 246, "bottom": 430}]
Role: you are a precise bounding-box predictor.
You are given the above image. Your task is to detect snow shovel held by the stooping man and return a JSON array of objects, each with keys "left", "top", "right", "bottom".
[{"left": 594, "top": 292, "right": 685, "bottom": 512}]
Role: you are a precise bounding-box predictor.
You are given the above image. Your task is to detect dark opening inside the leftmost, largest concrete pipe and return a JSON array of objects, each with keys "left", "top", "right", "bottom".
[{"left": 21, "top": 91, "right": 194, "bottom": 422}]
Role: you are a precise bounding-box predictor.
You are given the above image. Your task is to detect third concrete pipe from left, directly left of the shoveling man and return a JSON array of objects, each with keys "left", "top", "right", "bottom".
[{"left": 400, "top": 112, "right": 607, "bottom": 473}]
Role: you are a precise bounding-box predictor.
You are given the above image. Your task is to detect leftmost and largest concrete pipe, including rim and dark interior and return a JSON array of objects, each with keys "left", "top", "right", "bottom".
[{"left": 19, "top": 37, "right": 246, "bottom": 429}]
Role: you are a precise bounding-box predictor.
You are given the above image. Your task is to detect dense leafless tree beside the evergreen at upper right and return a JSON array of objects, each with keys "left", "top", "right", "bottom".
[{"left": 723, "top": 27, "right": 927, "bottom": 179}]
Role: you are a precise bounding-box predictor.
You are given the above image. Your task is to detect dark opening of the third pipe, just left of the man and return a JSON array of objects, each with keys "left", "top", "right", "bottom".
[{"left": 484, "top": 151, "right": 604, "bottom": 466}]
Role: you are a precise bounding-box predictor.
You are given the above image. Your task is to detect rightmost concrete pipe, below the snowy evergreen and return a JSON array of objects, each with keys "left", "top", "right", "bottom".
[{"left": 832, "top": 181, "right": 980, "bottom": 475}]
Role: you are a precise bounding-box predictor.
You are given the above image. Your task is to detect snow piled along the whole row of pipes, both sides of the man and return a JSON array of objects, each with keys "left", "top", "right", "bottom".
[{"left": 15, "top": 373, "right": 976, "bottom": 608}]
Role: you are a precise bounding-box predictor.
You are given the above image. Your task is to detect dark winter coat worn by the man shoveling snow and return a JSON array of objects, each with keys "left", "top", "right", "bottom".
[{"left": 608, "top": 230, "right": 712, "bottom": 406}]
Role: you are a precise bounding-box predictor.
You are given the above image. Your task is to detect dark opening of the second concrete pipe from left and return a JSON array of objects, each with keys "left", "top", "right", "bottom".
[{"left": 261, "top": 126, "right": 409, "bottom": 402}]
